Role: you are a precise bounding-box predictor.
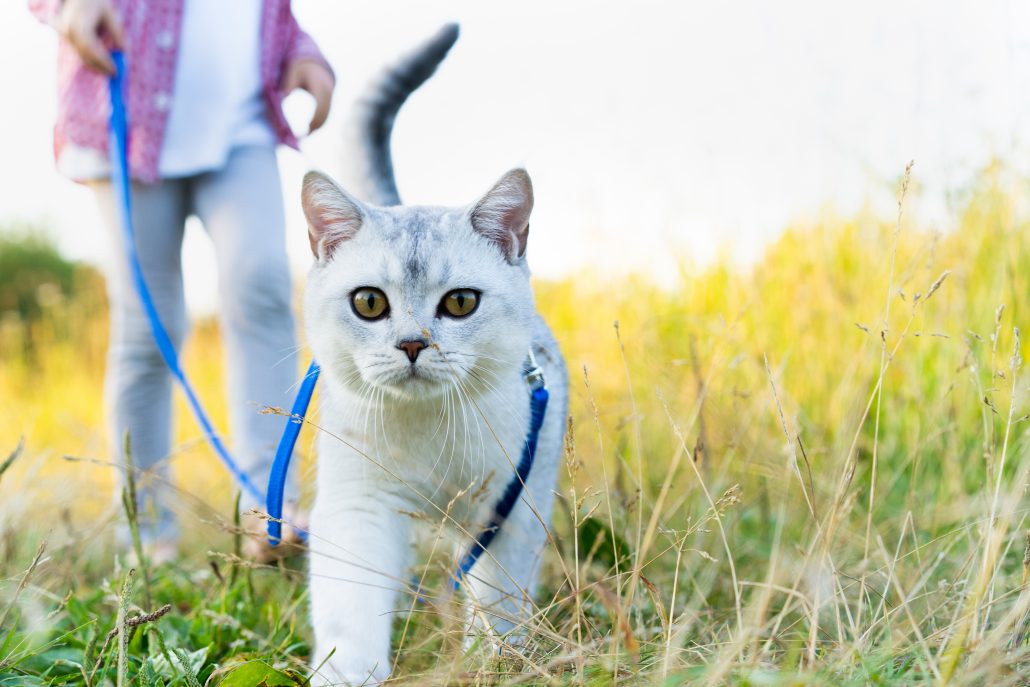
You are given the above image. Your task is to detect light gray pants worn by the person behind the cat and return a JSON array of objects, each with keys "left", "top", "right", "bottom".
[{"left": 93, "top": 146, "right": 298, "bottom": 537}]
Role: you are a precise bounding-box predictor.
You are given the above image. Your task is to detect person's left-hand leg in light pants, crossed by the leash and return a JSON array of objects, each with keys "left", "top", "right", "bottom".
[{"left": 91, "top": 181, "right": 187, "bottom": 541}]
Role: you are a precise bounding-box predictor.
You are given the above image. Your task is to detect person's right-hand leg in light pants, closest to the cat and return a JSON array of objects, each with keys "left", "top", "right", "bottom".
[{"left": 193, "top": 146, "right": 298, "bottom": 509}]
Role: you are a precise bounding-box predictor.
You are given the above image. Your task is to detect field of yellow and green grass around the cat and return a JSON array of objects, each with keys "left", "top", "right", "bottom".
[{"left": 6, "top": 163, "right": 1030, "bottom": 687}]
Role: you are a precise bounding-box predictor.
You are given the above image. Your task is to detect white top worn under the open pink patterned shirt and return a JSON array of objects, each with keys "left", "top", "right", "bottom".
[{"left": 158, "top": 0, "right": 276, "bottom": 178}]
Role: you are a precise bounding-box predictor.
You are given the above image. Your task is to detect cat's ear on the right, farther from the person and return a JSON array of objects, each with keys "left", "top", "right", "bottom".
[{"left": 469, "top": 169, "right": 533, "bottom": 263}]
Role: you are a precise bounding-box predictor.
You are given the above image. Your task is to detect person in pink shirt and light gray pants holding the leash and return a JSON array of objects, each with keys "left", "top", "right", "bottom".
[{"left": 29, "top": 0, "right": 335, "bottom": 558}]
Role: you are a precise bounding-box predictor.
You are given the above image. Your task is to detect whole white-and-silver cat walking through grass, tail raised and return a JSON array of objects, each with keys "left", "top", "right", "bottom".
[{"left": 302, "top": 25, "right": 568, "bottom": 684}]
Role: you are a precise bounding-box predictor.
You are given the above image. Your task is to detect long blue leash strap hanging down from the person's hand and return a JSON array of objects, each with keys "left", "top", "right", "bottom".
[{"left": 110, "top": 51, "right": 264, "bottom": 502}]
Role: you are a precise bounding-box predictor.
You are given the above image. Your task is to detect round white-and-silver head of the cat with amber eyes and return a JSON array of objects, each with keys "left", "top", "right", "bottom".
[{"left": 302, "top": 169, "right": 535, "bottom": 400}]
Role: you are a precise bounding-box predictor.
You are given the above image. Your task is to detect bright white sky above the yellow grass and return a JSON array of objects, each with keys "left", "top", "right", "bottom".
[{"left": 0, "top": 0, "right": 1030, "bottom": 309}]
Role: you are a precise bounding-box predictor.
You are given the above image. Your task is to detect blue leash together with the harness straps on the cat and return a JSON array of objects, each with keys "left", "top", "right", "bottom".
[{"left": 110, "top": 51, "right": 549, "bottom": 589}]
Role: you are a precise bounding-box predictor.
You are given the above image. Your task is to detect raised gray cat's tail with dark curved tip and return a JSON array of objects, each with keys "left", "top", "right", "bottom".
[{"left": 345, "top": 24, "right": 458, "bottom": 205}]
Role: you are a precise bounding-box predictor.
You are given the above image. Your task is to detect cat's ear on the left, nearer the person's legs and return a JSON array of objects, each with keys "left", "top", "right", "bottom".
[{"left": 301, "top": 172, "right": 365, "bottom": 263}]
